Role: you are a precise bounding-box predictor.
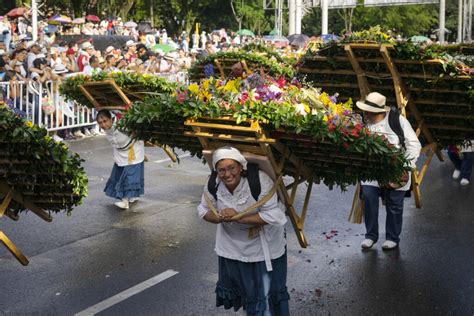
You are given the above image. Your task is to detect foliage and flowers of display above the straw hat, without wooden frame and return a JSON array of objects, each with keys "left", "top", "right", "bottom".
[{"left": 298, "top": 27, "right": 474, "bottom": 146}]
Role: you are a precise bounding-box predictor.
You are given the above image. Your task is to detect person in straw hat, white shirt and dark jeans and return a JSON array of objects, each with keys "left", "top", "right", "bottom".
[{"left": 356, "top": 92, "right": 421, "bottom": 250}]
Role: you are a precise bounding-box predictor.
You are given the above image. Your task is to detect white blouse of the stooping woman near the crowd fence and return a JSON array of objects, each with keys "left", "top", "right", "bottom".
[{"left": 105, "top": 124, "right": 145, "bottom": 167}]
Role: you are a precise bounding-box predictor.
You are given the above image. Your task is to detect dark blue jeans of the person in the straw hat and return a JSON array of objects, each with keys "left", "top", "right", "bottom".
[{"left": 362, "top": 185, "right": 406, "bottom": 243}]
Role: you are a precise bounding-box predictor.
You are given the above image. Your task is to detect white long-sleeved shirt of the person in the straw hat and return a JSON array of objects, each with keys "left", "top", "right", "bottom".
[{"left": 362, "top": 112, "right": 421, "bottom": 191}]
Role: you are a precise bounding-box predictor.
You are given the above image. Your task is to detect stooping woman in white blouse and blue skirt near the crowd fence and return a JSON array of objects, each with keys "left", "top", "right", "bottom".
[{"left": 96, "top": 110, "right": 145, "bottom": 209}]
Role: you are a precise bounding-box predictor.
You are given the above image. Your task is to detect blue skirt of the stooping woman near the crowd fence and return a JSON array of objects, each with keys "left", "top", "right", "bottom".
[{"left": 104, "top": 161, "right": 145, "bottom": 199}]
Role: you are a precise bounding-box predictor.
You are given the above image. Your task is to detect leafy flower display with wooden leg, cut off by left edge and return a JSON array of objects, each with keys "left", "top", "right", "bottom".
[{"left": 0, "top": 104, "right": 87, "bottom": 265}]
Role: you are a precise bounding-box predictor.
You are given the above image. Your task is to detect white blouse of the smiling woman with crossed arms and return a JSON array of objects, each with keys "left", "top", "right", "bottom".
[{"left": 198, "top": 171, "right": 287, "bottom": 262}]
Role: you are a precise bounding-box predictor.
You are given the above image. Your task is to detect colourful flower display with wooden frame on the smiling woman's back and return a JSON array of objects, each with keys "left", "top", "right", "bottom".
[{"left": 93, "top": 74, "right": 409, "bottom": 247}]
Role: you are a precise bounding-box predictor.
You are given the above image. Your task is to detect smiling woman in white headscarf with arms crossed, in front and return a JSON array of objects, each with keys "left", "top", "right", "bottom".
[{"left": 198, "top": 147, "right": 289, "bottom": 315}]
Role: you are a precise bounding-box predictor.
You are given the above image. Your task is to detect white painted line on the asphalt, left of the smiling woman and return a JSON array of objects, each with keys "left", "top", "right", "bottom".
[{"left": 75, "top": 270, "right": 179, "bottom": 316}]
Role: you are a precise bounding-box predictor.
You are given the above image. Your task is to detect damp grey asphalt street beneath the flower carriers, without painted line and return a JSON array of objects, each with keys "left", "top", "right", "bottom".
[{"left": 0, "top": 137, "right": 474, "bottom": 315}]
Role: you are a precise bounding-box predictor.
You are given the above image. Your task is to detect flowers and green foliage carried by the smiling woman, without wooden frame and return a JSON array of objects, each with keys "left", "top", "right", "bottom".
[{"left": 120, "top": 74, "right": 409, "bottom": 188}]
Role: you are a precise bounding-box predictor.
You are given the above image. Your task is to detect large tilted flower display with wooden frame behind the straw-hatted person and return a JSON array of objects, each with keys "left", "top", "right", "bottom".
[{"left": 298, "top": 27, "right": 474, "bottom": 207}]
